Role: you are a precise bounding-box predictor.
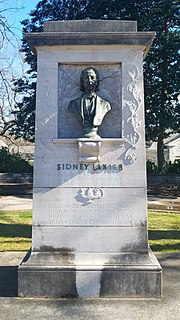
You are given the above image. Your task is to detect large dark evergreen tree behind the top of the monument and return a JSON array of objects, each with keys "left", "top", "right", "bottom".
[{"left": 13, "top": 0, "right": 179, "bottom": 172}]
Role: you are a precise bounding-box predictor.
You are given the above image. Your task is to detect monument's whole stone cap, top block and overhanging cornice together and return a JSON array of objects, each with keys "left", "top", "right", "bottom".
[{"left": 26, "top": 20, "right": 155, "bottom": 55}]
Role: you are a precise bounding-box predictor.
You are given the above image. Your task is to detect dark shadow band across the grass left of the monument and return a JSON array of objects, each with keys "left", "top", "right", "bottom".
[{"left": 0, "top": 223, "right": 32, "bottom": 238}]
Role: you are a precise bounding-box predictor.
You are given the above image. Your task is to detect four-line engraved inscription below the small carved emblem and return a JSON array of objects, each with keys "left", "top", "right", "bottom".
[{"left": 46, "top": 201, "right": 139, "bottom": 226}]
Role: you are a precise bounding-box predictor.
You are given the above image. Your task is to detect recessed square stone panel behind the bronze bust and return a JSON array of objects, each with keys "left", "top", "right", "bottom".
[{"left": 58, "top": 63, "right": 122, "bottom": 138}]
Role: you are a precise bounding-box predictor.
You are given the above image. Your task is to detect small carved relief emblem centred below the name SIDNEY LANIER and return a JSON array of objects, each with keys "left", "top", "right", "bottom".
[{"left": 76, "top": 188, "right": 104, "bottom": 206}]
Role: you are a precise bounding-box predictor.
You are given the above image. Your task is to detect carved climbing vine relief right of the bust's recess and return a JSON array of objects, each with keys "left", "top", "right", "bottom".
[{"left": 124, "top": 65, "right": 143, "bottom": 164}]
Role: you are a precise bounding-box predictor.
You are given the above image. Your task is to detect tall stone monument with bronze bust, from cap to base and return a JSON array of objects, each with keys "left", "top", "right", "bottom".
[{"left": 18, "top": 20, "right": 162, "bottom": 298}]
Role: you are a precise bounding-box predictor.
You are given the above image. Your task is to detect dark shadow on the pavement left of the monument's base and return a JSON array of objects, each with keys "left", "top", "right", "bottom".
[{"left": 0, "top": 266, "right": 18, "bottom": 297}]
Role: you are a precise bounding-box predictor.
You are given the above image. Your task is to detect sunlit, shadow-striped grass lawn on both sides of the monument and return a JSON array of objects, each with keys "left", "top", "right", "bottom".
[{"left": 0, "top": 211, "right": 180, "bottom": 252}]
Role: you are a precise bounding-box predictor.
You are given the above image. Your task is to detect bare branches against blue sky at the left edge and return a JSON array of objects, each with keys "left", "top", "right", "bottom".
[{"left": 0, "top": 1, "right": 22, "bottom": 135}]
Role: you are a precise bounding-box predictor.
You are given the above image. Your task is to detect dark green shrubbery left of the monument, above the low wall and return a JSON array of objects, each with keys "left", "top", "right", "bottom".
[{"left": 0, "top": 147, "right": 33, "bottom": 173}]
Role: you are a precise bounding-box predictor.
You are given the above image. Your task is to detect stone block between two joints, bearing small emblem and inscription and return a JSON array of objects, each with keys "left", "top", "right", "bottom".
[{"left": 34, "top": 187, "right": 146, "bottom": 226}]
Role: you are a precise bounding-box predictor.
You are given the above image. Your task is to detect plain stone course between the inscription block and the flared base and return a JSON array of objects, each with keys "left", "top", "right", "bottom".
[{"left": 32, "top": 225, "right": 147, "bottom": 254}]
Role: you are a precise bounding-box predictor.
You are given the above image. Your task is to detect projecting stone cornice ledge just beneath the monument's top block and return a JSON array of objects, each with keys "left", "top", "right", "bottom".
[{"left": 25, "top": 32, "right": 156, "bottom": 55}]
